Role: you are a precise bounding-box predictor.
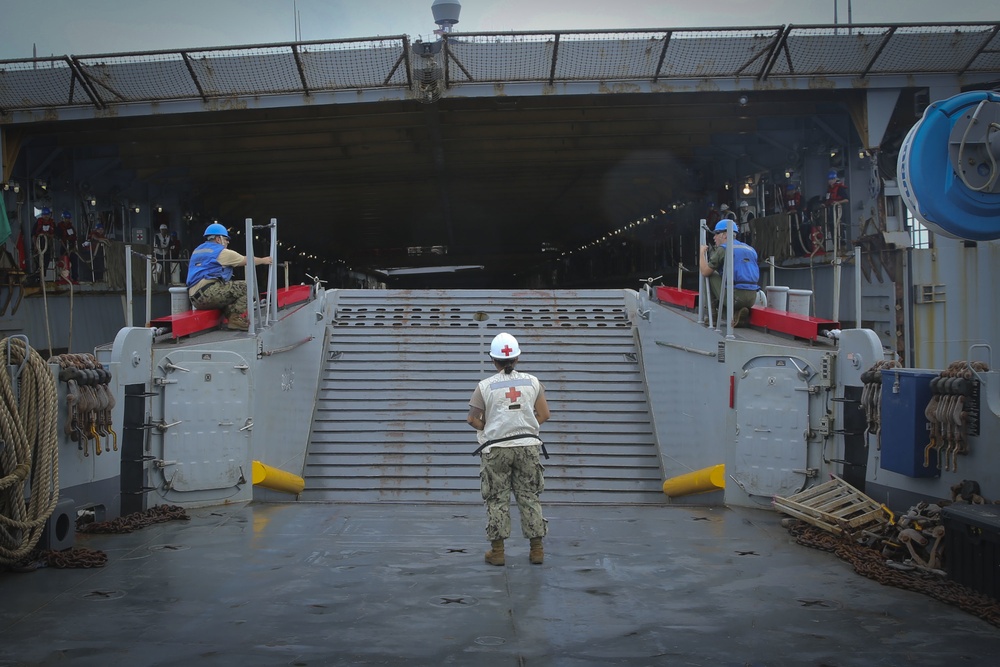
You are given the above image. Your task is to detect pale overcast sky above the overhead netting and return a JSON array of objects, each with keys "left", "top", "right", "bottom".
[{"left": 0, "top": 0, "right": 1000, "bottom": 60}]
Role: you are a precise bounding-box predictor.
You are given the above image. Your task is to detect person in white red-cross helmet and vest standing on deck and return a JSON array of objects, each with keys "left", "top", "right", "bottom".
[{"left": 466, "top": 333, "right": 550, "bottom": 565}]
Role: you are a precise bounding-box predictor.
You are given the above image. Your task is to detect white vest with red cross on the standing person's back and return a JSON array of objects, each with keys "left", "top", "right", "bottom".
[{"left": 476, "top": 371, "right": 541, "bottom": 454}]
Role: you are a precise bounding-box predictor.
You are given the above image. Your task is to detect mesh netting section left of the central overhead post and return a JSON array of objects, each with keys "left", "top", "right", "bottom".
[{"left": 0, "top": 37, "right": 410, "bottom": 110}]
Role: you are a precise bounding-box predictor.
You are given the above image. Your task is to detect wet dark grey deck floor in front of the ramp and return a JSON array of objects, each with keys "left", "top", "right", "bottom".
[{"left": 0, "top": 503, "right": 1000, "bottom": 667}]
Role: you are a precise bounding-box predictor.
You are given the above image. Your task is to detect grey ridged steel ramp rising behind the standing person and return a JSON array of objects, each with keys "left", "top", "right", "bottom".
[{"left": 300, "top": 290, "right": 666, "bottom": 504}]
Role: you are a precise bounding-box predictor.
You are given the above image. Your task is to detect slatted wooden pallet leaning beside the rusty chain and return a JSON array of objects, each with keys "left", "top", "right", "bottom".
[{"left": 772, "top": 475, "right": 888, "bottom": 537}]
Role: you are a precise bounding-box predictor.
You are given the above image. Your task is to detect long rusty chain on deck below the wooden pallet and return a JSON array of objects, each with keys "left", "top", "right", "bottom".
[{"left": 788, "top": 520, "right": 1000, "bottom": 627}]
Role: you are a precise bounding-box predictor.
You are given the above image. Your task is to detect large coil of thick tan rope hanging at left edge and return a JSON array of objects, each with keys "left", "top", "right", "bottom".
[{"left": 0, "top": 336, "right": 59, "bottom": 564}]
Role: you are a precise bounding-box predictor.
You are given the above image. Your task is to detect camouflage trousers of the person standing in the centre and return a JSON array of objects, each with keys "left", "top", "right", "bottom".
[{"left": 479, "top": 445, "right": 548, "bottom": 540}]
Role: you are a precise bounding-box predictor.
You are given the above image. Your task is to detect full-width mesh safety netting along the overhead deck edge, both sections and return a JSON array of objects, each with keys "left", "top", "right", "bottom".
[{"left": 0, "top": 23, "right": 1000, "bottom": 112}]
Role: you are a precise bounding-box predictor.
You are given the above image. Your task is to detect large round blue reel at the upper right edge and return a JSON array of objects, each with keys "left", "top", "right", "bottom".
[{"left": 897, "top": 91, "right": 1000, "bottom": 241}]
